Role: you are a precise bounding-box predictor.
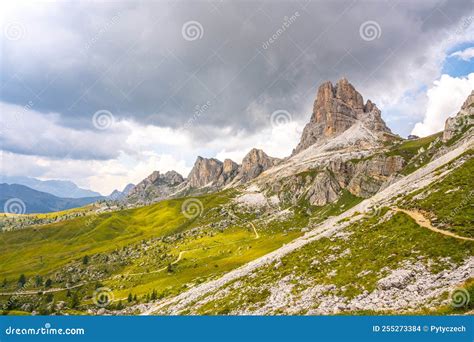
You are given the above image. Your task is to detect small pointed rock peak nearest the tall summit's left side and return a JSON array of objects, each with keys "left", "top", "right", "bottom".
[{"left": 235, "top": 148, "right": 281, "bottom": 183}]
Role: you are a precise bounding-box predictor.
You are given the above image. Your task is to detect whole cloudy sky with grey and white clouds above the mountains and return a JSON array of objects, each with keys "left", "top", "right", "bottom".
[{"left": 0, "top": 0, "right": 474, "bottom": 194}]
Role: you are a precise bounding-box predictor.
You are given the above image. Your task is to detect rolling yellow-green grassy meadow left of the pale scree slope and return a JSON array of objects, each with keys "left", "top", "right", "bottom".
[{"left": 0, "top": 191, "right": 310, "bottom": 313}]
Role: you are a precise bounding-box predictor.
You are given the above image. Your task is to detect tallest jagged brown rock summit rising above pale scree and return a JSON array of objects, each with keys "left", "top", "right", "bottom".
[{"left": 293, "top": 78, "right": 392, "bottom": 155}]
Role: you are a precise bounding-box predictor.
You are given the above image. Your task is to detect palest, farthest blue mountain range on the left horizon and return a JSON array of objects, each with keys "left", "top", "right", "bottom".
[{"left": 0, "top": 176, "right": 102, "bottom": 198}]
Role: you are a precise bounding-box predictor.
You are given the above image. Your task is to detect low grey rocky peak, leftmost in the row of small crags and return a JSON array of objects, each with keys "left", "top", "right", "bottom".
[{"left": 127, "top": 171, "right": 184, "bottom": 202}]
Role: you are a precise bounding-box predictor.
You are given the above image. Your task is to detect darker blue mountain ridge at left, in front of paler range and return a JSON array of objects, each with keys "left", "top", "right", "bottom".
[{"left": 0, "top": 183, "right": 104, "bottom": 214}]
